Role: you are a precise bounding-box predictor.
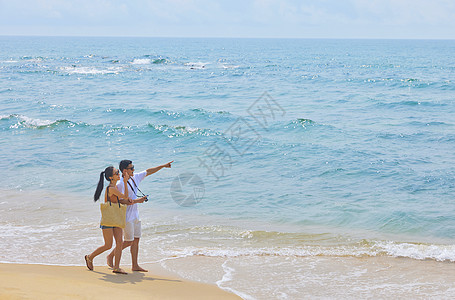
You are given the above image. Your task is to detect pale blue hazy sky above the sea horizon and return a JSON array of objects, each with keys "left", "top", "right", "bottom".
[{"left": 0, "top": 0, "right": 455, "bottom": 39}]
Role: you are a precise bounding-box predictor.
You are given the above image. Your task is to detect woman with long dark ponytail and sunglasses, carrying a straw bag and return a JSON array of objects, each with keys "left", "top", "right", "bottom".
[{"left": 85, "top": 166, "right": 134, "bottom": 274}]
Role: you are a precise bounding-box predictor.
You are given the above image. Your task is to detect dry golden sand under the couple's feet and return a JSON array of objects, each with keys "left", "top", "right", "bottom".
[{"left": 0, "top": 264, "right": 240, "bottom": 300}]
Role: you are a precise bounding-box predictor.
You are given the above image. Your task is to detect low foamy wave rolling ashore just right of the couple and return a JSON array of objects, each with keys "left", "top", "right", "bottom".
[{"left": 151, "top": 225, "right": 455, "bottom": 262}]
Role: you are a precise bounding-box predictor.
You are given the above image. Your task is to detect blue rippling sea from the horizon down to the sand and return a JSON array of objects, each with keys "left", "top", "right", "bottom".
[{"left": 0, "top": 36, "right": 455, "bottom": 299}]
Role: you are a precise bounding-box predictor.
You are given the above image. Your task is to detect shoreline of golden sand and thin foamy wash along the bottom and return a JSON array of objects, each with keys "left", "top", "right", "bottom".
[{"left": 0, "top": 256, "right": 455, "bottom": 300}]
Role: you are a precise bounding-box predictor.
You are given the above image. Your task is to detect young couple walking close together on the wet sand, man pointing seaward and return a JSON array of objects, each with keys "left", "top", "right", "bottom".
[{"left": 85, "top": 160, "right": 174, "bottom": 274}]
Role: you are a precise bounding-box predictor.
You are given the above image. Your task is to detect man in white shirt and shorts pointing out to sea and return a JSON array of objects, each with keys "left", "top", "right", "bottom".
[{"left": 107, "top": 160, "right": 174, "bottom": 272}]
